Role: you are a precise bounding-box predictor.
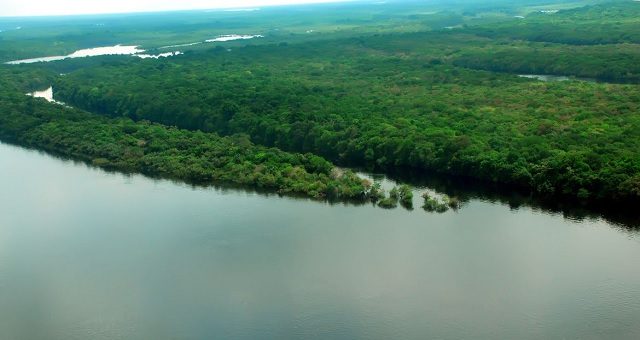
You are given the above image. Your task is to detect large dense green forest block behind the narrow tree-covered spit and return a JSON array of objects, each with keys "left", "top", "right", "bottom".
[{"left": 50, "top": 34, "right": 640, "bottom": 206}]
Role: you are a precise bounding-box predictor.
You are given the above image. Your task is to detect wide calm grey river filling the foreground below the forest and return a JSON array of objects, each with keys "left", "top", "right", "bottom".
[{"left": 0, "top": 144, "right": 640, "bottom": 339}]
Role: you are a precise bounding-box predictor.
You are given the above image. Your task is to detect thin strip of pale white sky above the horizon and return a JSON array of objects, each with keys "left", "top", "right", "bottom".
[{"left": 0, "top": 0, "right": 350, "bottom": 16}]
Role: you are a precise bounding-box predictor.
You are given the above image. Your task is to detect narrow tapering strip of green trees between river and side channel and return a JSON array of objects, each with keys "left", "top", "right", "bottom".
[{"left": 0, "top": 69, "right": 370, "bottom": 201}]
